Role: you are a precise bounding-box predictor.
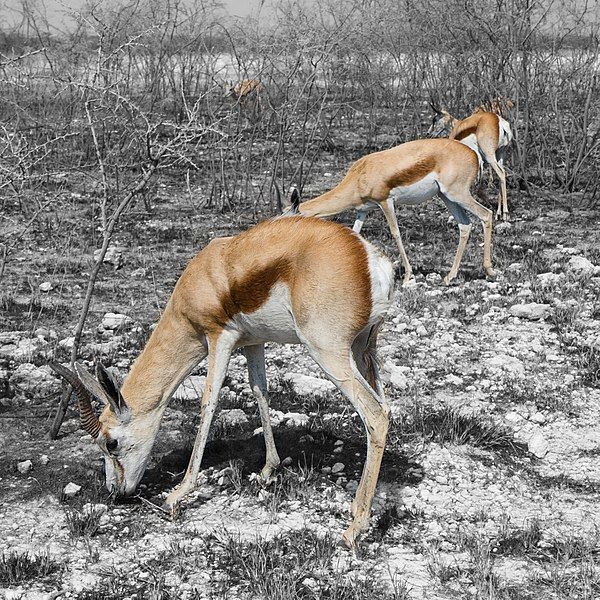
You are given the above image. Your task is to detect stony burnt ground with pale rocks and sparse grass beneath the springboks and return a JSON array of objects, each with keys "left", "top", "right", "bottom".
[{"left": 0, "top": 180, "right": 600, "bottom": 600}]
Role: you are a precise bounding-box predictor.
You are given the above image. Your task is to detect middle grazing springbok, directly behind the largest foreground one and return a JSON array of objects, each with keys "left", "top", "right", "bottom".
[{"left": 292, "top": 139, "right": 495, "bottom": 285}]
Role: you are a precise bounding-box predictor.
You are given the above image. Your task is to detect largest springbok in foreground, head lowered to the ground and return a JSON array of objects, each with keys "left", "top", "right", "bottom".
[{"left": 52, "top": 216, "right": 394, "bottom": 547}]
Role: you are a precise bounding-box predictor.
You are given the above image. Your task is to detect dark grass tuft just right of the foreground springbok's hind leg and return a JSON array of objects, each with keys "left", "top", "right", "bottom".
[{"left": 390, "top": 402, "right": 524, "bottom": 453}]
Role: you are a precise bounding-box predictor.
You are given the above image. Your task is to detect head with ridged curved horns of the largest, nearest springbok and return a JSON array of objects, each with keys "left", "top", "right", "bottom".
[{"left": 49, "top": 362, "right": 160, "bottom": 496}]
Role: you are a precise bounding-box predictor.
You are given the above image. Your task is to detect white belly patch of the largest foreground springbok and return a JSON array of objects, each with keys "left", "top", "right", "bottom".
[{"left": 232, "top": 283, "right": 300, "bottom": 344}]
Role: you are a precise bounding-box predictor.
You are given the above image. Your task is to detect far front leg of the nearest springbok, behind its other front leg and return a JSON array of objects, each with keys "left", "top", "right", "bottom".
[{"left": 244, "top": 344, "right": 281, "bottom": 484}]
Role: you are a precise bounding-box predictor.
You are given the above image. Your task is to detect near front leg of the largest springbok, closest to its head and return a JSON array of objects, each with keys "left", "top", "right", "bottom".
[{"left": 163, "top": 331, "right": 237, "bottom": 517}]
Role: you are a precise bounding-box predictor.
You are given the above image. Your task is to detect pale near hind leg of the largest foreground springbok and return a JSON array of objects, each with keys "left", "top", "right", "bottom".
[{"left": 311, "top": 348, "right": 390, "bottom": 550}]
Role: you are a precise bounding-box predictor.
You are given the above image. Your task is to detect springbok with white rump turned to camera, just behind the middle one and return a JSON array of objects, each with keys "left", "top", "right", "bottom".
[{"left": 428, "top": 98, "right": 513, "bottom": 220}]
